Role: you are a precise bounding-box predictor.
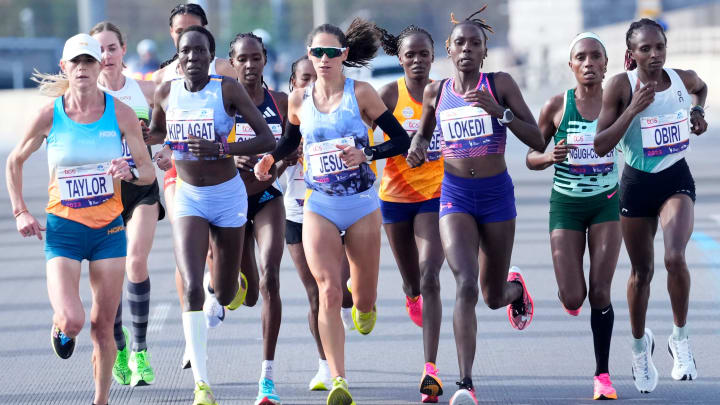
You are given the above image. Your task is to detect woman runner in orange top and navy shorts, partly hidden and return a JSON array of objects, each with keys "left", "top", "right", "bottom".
[{"left": 378, "top": 25, "right": 445, "bottom": 403}]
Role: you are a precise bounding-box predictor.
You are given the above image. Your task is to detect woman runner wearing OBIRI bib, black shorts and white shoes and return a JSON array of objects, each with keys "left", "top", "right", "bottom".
[{"left": 595, "top": 18, "right": 708, "bottom": 393}]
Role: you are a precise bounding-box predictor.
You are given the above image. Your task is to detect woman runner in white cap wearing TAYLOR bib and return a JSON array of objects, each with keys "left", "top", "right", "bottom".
[{"left": 6, "top": 34, "right": 155, "bottom": 404}]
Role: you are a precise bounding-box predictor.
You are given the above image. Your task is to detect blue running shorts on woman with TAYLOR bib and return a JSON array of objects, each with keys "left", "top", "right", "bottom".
[{"left": 45, "top": 214, "right": 127, "bottom": 262}]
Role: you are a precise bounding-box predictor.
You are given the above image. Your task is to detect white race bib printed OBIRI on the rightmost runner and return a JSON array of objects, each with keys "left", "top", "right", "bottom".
[{"left": 640, "top": 110, "right": 690, "bottom": 156}]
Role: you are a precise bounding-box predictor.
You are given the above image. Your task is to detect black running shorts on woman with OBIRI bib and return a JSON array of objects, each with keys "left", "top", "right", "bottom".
[{"left": 620, "top": 159, "right": 695, "bottom": 217}]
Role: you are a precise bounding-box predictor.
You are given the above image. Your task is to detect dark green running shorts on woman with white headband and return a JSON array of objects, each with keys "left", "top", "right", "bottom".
[{"left": 550, "top": 186, "right": 620, "bottom": 233}]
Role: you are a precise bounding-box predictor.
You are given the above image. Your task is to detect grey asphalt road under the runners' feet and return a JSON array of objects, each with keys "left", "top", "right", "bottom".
[{"left": 0, "top": 126, "right": 720, "bottom": 404}]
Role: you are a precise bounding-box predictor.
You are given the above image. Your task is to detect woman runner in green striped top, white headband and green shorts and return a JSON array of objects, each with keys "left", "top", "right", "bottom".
[{"left": 526, "top": 32, "right": 622, "bottom": 399}]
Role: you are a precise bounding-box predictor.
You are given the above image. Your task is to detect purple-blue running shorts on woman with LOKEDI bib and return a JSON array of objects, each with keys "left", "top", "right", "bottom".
[{"left": 440, "top": 170, "right": 517, "bottom": 224}]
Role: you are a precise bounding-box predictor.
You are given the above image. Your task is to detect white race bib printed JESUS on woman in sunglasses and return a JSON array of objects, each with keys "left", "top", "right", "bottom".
[{"left": 305, "top": 136, "right": 359, "bottom": 183}]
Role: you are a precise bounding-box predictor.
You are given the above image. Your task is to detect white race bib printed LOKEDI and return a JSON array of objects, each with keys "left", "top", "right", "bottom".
[{"left": 440, "top": 106, "right": 493, "bottom": 149}]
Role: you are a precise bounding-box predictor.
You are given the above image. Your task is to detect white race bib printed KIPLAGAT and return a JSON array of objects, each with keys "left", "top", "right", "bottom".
[{"left": 165, "top": 108, "right": 215, "bottom": 152}]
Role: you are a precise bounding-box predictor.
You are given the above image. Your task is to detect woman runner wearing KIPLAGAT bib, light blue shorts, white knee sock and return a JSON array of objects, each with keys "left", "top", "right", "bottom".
[{"left": 150, "top": 26, "right": 275, "bottom": 405}]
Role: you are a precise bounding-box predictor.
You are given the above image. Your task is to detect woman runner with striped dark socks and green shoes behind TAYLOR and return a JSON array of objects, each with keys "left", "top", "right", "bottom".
[{"left": 90, "top": 21, "right": 165, "bottom": 387}]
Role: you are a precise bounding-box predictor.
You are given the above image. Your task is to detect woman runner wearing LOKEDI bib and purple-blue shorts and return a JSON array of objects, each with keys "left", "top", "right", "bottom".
[{"left": 407, "top": 6, "right": 545, "bottom": 405}]
